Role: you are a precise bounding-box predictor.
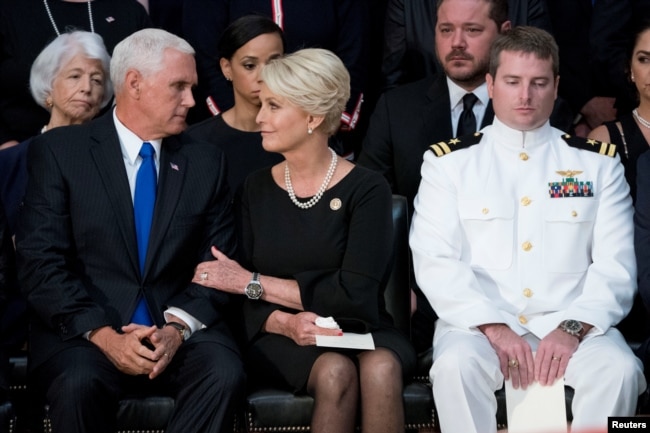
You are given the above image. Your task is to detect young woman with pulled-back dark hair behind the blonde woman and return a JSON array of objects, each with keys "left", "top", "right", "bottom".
[{"left": 188, "top": 15, "right": 284, "bottom": 192}]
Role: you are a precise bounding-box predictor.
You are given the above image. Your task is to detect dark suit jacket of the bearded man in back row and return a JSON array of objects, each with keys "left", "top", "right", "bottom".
[{"left": 357, "top": 74, "right": 494, "bottom": 209}]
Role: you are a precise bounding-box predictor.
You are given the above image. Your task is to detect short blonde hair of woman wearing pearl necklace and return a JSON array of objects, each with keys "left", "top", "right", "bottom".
[{"left": 261, "top": 48, "right": 350, "bottom": 135}]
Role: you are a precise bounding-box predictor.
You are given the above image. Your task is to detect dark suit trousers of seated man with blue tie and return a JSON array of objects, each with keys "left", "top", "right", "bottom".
[{"left": 31, "top": 340, "right": 245, "bottom": 433}]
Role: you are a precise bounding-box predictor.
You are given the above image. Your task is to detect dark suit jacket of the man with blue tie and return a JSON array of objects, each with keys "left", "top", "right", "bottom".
[{"left": 17, "top": 112, "right": 235, "bottom": 366}]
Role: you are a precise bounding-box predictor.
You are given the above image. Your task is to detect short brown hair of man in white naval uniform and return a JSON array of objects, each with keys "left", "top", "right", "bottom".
[{"left": 490, "top": 26, "right": 560, "bottom": 77}]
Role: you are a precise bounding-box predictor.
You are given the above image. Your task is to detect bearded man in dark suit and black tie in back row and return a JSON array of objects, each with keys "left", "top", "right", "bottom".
[{"left": 358, "top": 0, "right": 510, "bottom": 351}]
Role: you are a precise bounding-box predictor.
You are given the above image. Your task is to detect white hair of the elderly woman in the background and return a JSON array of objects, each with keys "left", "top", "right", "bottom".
[{"left": 29, "top": 31, "right": 113, "bottom": 108}]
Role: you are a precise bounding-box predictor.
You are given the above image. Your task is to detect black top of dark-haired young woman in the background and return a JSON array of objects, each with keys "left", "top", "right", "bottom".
[{"left": 187, "top": 115, "right": 284, "bottom": 192}]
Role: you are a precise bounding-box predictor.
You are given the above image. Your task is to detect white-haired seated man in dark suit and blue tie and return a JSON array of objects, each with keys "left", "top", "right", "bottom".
[{"left": 17, "top": 29, "right": 245, "bottom": 433}]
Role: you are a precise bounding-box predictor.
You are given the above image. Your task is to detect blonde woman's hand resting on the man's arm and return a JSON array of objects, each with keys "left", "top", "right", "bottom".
[{"left": 192, "top": 247, "right": 252, "bottom": 295}]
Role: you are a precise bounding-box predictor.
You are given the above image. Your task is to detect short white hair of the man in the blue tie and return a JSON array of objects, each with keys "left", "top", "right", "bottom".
[{"left": 111, "top": 28, "right": 195, "bottom": 92}]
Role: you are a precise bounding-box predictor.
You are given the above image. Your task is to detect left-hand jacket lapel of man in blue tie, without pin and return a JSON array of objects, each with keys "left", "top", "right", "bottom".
[{"left": 90, "top": 111, "right": 140, "bottom": 275}]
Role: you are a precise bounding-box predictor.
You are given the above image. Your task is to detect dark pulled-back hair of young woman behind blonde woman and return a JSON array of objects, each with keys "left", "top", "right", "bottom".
[{"left": 217, "top": 15, "right": 286, "bottom": 60}]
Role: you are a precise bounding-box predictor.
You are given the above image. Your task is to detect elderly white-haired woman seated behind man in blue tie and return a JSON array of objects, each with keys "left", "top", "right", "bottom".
[{"left": 0, "top": 31, "right": 113, "bottom": 234}]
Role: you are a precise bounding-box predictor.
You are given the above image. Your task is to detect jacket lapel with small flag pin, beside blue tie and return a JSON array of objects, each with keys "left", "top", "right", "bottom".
[{"left": 144, "top": 136, "right": 187, "bottom": 277}]
